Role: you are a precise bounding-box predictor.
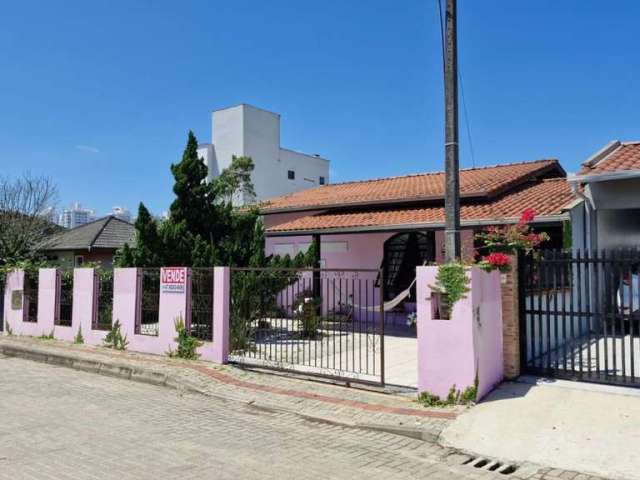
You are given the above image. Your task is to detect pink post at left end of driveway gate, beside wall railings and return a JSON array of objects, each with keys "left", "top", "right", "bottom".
[{"left": 212, "top": 267, "right": 231, "bottom": 363}]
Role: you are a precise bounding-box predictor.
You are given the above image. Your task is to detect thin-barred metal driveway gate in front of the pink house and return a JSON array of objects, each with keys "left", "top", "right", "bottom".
[{"left": 230, "top": 268, "right": 384, "bottom": 384}]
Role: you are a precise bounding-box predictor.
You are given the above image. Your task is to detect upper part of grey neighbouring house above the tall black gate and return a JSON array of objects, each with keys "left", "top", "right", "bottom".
[{"left": 568, "top": 140, "right": 640, "bottom": 252}]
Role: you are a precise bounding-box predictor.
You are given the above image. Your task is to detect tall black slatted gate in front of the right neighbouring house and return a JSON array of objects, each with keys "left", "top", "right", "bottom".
[{"left": 520, "top": 251, "right": 640, "bottom": 386}]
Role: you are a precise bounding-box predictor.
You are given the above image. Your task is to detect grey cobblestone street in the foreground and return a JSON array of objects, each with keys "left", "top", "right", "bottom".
[{"left": 0, "top": 356, "right": 608, "bottom": 480}]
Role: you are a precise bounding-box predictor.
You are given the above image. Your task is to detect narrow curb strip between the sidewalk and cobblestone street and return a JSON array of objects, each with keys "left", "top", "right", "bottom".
[{"left": 0, "top": 343, "right": 438, "bottom": 443}]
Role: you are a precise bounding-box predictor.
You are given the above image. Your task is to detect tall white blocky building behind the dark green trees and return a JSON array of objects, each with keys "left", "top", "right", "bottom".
[{"left": 198, "top": 104, "right": 329, "bottom": 205}]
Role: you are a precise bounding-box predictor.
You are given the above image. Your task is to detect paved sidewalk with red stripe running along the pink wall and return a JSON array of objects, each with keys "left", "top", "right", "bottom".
[{"left": 0, "top": 336, "right": 456, "bottom": 441}]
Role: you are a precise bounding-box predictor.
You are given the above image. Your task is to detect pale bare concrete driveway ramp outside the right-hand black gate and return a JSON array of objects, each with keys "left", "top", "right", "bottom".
[{"left": 442, "top": 379, "right": 640, "bottom": 479}]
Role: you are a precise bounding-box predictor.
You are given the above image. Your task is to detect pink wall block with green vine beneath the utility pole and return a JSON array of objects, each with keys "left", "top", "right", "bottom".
[{"left": 417, "top": 267, "right": 503, "bottom": 400}]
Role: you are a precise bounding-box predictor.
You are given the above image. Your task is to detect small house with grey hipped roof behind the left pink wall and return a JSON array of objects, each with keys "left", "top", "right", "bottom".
[{"left": 43, "top": 215, "right": 135, "bottom": 268}]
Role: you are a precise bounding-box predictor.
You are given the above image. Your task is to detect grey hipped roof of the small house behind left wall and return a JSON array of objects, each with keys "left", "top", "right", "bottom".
[{"left": 43, "top": 215, "right": 135, "bottom": 250}]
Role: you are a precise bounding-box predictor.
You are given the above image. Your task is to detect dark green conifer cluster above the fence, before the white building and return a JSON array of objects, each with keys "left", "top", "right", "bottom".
[{"left": 116, "top": 132, "right": 315, "bottom": 272}]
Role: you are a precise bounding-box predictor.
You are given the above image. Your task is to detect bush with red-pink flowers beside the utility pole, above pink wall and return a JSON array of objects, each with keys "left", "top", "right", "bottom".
[{"left": 476, "top": 208, "right": 549, "bottom": 272}]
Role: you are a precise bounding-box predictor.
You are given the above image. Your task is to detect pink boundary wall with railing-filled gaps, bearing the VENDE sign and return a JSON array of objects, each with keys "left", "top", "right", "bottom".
[{"left": 4, "top": 267, "right": 230, "bottom": 363}]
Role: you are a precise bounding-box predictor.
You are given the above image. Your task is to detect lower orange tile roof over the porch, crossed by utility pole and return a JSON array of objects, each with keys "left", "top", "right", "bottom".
[{"left": 267, "top": 178, "right": 573, "bottom": 233}]
